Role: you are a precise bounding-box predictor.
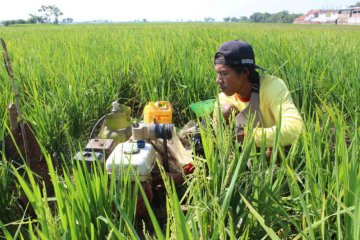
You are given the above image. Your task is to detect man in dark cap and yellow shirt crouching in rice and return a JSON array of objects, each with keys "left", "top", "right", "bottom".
[{"left": 214, "top": 40, "right": 304, "bottom": 147}]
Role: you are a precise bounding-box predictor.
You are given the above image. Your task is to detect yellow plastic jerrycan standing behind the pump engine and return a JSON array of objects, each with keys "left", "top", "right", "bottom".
[{"left": 144, "top": 101, "right": 173, "bottom": 124}]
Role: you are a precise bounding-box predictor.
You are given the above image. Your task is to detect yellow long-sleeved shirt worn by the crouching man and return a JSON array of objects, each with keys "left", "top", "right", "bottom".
[{"left": 214, "top": 75, "right": 304, "bottom": 147}]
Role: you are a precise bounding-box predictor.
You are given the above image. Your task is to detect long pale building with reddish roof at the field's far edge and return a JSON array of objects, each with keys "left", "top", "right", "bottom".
[{"left": 293, "top": 7, "right": 360, "bottom": 25}]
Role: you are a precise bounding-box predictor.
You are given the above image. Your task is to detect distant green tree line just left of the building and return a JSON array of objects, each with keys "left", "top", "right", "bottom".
[{"left": 223, "top": 11, "right": 303, "bottom": 23}]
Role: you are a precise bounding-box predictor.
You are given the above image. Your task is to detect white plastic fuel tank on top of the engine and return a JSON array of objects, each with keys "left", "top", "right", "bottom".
[{"left": 105, "top": 142, "right": 156, "bottom": 181}]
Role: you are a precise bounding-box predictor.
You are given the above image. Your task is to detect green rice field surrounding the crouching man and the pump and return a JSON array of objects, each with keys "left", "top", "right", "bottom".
[{"left": 0, "top": 23, "right": 360, "bottom": 240}]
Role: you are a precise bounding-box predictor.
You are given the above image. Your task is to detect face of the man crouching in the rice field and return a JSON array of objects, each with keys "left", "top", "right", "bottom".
[{"left": 215, "top": 64, "right": 250, "bottom": 96}]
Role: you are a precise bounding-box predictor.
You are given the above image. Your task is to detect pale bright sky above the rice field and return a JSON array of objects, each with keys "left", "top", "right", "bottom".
[{"left": 0, "top": 0, "right": 359, "bottom": 22}]
